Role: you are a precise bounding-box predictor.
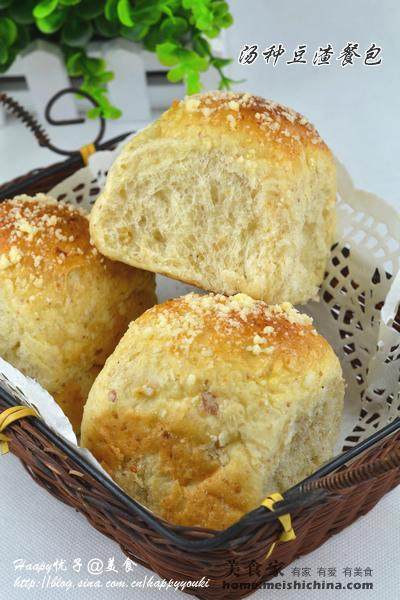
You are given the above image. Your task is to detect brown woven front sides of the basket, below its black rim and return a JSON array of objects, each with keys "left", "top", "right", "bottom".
[{"left": 0, "top": 400, "right": 400, "bottom": 599}]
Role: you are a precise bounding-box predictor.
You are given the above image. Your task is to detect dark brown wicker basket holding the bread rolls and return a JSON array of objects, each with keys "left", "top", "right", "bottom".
[{"left": 0, "top": 101, "right": 400, "bottom": 599}]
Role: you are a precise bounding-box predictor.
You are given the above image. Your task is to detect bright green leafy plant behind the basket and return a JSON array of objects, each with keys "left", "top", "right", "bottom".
[{"left": 0, "top": 0, "right": 233, "bottom": 119}]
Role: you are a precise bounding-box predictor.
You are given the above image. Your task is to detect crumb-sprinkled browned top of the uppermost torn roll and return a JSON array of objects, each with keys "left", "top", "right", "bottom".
[{"left": 181, "top": 91, "right": 323, "bottom": 144}]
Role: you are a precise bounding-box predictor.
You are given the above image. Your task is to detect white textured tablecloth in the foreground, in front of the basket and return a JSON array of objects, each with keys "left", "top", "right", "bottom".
[{"left": 0, "top": 454, "right": 400, "bottom": 600}]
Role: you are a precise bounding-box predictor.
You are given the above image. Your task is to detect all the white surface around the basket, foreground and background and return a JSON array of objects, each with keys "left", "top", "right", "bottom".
[{"left": 0, "top": 0, "right": 400, "bottom": 600}]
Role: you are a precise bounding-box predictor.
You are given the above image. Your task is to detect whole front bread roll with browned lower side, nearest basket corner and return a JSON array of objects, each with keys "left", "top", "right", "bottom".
[{"left": 81, "top": 294, "right": 344, "bottom": 529}]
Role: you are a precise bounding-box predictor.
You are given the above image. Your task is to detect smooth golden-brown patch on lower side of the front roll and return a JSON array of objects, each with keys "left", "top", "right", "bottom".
[{"left": 83, "top": 409, "right": 258, "bottom": 529}]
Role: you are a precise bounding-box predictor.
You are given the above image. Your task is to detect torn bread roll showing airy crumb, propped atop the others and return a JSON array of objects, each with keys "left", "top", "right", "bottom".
[{"left": 90, "top": 92, "right": 336, "bottom": 304}]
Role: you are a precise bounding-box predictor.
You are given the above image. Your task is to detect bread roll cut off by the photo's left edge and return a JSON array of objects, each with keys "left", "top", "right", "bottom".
[{"left": 0, "top": 194, "right": 156, "bottom": 431}]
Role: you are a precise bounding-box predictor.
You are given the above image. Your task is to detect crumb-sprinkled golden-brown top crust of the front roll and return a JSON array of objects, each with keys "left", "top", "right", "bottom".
[{"left": 137, "top": 294, "right": 330, "bottom": 361}]
